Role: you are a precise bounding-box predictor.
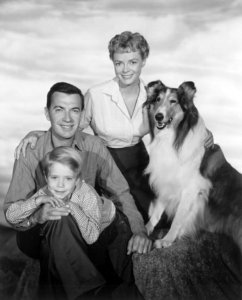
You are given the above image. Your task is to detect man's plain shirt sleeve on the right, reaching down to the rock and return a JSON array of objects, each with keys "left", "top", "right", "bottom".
[{"left": 92, "top": 140, "right": 146, "bottom": 234}]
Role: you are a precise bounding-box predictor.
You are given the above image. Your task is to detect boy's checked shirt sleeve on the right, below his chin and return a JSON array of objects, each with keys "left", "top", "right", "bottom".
[{"left": 69, "top": 183, "right": 101, "bottom": 244}]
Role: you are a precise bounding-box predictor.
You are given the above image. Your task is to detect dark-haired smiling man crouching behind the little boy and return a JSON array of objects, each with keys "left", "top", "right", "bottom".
[{"left": 4, "top": 82, "right": 151, "bottom": 299}]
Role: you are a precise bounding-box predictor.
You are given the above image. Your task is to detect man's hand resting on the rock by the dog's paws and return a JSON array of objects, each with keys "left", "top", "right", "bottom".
[{"left": 127, "top": 233, "right": 152, "bottom": 255}]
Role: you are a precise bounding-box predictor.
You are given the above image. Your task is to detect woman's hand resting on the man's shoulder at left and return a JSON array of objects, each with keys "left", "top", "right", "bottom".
[{"left": 14, "top": 131, "right": 44, "bottom": 159}]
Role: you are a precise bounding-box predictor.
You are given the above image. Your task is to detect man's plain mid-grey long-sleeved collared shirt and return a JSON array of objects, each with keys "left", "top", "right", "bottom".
[{"left": 4, "top": 130, "right": 146, "bottom": 233}]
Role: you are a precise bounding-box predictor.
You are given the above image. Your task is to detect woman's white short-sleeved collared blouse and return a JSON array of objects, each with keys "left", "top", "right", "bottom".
[{"left": 80, "top": 78, "right": 149, "bottom": 148}]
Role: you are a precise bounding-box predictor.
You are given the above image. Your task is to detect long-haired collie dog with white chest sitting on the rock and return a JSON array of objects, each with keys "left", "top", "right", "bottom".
[{"left": 144, "top": 80, "right": 242, "bottom": 253}]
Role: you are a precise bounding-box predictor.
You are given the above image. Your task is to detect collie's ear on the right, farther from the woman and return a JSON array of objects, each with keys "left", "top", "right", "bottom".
[{"left": 178, "top": 81, "right": 197, "bottom": 109}]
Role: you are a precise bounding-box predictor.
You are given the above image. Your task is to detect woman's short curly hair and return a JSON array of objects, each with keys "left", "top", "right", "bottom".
[{"left": 108, "top": 31, "right": 150, "bottom": 60}]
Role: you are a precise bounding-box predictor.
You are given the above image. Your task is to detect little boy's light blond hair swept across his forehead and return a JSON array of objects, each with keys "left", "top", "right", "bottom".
[{"left": 42, "top": 146, "right": 83, "bottom": 176}]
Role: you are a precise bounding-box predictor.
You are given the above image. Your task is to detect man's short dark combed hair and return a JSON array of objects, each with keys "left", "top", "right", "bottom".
[{"left": 46, "top": 82, "right": 84, "bottom": 110}]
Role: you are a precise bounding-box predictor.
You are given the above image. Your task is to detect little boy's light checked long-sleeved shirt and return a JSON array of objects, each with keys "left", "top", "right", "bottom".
[{"left": 6, "top": 181, "right": 115, "bottom": 244}]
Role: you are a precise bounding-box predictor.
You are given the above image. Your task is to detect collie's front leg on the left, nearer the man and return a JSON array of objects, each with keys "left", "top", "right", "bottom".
[{"left": 145, "top": 199, "right": 165, "bottom": 235}]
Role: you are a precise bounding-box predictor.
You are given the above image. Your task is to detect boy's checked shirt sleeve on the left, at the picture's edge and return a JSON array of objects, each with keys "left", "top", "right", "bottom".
[{"left": 6, "top": 189, "right": 45, "bottom": 227}]
